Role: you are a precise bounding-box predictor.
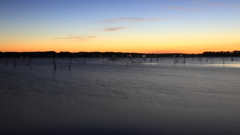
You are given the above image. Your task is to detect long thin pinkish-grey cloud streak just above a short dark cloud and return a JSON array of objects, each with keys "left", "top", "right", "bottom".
[{"left": 101, "top": 17, "right": 169, "bottom": 22}]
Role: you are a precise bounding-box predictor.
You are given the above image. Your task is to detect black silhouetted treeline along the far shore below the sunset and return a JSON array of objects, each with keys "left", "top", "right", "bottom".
[{"left": 0, "top": 51, "right": 240, "bottom": 58}]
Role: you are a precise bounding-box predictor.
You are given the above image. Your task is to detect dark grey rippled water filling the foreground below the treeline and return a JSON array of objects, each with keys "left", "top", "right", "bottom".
[{"left": 0, "top": 58, "right": 240, "bottom": 135}]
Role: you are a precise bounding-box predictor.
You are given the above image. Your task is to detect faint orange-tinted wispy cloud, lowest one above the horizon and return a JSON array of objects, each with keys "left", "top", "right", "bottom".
[{"left": 53, "top": 34, "right": 96, "bottom": 42}]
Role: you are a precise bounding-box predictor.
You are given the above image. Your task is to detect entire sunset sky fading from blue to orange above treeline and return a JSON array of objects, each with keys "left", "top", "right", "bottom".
[{"left": 0, "top": 0, "right": 240, "bottom": 53}]
